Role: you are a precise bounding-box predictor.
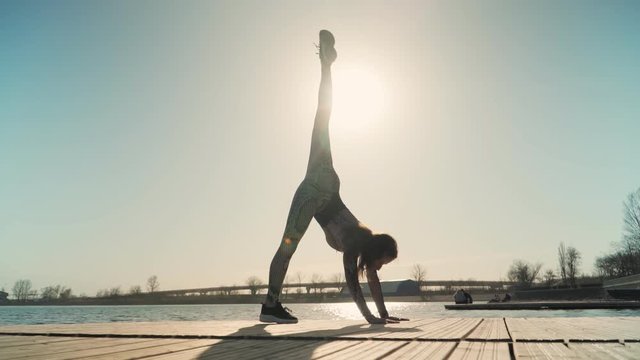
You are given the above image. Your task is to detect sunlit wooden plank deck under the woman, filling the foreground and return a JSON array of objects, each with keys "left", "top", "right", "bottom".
[{"left": 0, "top": 317, "right": 640, "bottom": 360}]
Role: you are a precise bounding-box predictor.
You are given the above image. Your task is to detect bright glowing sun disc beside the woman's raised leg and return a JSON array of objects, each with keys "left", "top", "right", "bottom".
[{"left": 331, "top": 67, "right": 387, "bottom": 136}]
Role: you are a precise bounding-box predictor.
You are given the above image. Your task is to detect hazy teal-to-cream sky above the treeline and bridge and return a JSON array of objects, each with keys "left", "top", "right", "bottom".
[{"left": 0, "top": 0, "right": 640, "bottom": 296}]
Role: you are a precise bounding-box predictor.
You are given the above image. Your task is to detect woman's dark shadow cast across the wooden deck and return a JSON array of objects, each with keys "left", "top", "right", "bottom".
[{"left": 198, "top": 323, "right": 419, "bottom": 360}]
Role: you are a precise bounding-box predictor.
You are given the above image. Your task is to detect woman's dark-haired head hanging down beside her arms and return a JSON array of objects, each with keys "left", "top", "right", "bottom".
[{"left": 358, "top": 231, "right": 398, "bottom": 274}]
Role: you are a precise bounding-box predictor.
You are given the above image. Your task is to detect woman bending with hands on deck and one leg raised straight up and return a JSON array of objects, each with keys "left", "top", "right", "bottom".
[{"left": 260, "top": 30, "right": 406, "bottom": 324}]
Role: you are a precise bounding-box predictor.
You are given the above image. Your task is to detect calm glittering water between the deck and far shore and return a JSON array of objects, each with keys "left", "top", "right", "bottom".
[{"left": 0, "top": 302, "right": 640, "bottom": 325}]
